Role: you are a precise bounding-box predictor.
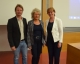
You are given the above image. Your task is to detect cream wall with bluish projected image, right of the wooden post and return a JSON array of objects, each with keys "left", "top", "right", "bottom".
[{"left": 53, "top": 0, "right": 80, "bottom": 27}]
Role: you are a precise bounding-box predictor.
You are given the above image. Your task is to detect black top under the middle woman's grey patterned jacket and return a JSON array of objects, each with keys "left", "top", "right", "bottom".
[{"left": 33, "top": 24, "right": 43, "bottom": 39}]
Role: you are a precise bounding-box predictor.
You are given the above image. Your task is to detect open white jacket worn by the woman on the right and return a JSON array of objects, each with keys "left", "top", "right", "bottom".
[{"left": 45, "top": 17, "right": 63, "bottom": 43}]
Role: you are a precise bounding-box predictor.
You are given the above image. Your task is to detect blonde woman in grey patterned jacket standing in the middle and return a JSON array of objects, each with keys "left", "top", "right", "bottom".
[{"left": 27, "top": 8, "right": 45, "bottom": 64}]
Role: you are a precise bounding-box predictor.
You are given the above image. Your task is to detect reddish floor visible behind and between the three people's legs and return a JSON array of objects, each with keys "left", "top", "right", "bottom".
[{"left": 0, "top": 51, "right": 66, "bottom": 64}]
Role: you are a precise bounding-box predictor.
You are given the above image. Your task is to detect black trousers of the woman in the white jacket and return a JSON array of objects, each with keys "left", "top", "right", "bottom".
[{"left": 47, "top": 41, "right": 61, "bottom": 64}]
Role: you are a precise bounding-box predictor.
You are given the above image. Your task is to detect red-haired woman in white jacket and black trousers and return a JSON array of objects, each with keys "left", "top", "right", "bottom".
[{"left": 46, "top": 7, "right": 63, "bottom": 64}]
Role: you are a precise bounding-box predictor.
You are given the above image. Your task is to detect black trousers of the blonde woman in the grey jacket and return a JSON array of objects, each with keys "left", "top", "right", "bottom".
[{"left": 31, "top": 40, "right": 42, "bottom": 64}]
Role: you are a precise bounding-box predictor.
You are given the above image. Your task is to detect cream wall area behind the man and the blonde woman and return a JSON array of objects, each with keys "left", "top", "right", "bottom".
[{"left": 0, "top": 0, "right": 41, "bottom": 25}]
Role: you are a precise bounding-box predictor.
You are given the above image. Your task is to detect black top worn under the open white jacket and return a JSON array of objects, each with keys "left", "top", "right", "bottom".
[{"left": 47, "top": 22, "right": 53, "bottom": 42}]
